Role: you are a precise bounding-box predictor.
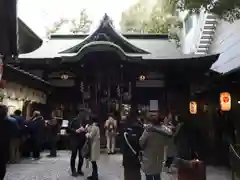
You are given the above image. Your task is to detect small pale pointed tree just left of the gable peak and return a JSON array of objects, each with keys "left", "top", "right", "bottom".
[{"left": 70, "top": 9, "right": 92, "bottom": 34}]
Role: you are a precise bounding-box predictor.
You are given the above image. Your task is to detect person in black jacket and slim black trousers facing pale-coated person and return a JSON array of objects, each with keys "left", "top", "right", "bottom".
[{"left": 68, "top": 110, "right": 87, "bottom": 177}]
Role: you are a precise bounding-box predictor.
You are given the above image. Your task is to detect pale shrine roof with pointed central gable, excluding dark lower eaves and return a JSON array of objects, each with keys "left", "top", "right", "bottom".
[{"left": 19, "top": 15, "right": 181, "bottom": 59}]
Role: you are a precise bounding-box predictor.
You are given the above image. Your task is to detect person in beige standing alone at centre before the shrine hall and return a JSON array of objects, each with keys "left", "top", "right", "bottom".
[{"left": 104, "top": 115, "right": 117, "bottom": 154}]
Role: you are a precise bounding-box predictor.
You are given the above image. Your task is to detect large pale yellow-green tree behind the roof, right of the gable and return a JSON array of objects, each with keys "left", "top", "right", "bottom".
[{"left": 120, "top": 0, "right": 182, "bottom": 46}]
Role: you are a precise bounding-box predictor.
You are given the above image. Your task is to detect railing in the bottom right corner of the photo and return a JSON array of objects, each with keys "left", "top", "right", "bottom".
[{"left": 229, "top": 145, "right": 240, "bottom": 180}]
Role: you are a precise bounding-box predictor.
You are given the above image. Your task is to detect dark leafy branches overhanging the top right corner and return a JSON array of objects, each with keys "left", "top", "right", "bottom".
[{"left": 178, "top": 0, "right": 240, "bottom": 22}]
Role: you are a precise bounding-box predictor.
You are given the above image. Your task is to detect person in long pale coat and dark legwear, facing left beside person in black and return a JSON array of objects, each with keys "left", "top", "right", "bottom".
[{"left": 86, "top": 118, "right": 100, "bottom": 180}]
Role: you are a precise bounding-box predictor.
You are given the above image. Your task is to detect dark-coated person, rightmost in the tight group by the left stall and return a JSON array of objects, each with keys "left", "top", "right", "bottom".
[{"left": 28, "top": 111, "right": 45, "bottom": 160}]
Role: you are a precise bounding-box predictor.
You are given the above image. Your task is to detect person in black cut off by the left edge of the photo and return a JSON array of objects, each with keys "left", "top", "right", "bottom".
[{"left": 0, "top": 105, "right": 19, "bottom": 180}]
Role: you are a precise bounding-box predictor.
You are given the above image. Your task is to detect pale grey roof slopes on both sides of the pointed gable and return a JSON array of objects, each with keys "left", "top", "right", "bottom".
[{"left": 19, "top": 34, "right": 182, "bottom": 59}]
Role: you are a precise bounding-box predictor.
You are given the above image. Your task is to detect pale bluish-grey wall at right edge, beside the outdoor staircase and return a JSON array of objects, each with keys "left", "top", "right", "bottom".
[{"left": 209, "top": 20, "right": 240, "bottom": 73}]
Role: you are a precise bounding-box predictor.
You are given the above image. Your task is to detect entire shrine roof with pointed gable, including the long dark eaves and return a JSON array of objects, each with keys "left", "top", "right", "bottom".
[{"left": 16, "top": 15, "right": 218, "bottom": 72}]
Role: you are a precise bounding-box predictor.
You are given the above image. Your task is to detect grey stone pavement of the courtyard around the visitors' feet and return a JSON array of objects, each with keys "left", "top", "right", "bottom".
[{"left": 5, "top": 151, "right": 231, "bottom": 180}]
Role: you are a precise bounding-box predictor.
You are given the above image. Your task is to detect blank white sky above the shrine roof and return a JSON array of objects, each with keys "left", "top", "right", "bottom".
[{"left": 18, "top": 0, "right": 137, "bottom": 38}]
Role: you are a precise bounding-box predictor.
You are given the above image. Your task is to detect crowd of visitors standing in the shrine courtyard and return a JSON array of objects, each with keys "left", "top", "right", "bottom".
[{"left": 0, "top": 105, "right": 202, "bottom": 180}]
